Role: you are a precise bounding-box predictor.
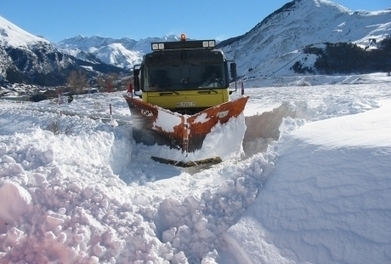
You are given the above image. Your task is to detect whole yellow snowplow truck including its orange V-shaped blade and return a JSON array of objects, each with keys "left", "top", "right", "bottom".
[{"left": 124, "top": 35, "right": 248, "bottom": 166}]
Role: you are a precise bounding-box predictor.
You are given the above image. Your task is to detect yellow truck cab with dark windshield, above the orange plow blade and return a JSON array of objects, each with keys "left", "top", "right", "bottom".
[{"left": 133, "top": 34, "right": 236, "bottom": 114}]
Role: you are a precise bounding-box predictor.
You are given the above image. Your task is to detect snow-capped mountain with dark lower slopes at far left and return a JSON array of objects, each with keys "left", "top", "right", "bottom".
[{"left": 0, "top": 17, "right": 123, "bottom": 86}]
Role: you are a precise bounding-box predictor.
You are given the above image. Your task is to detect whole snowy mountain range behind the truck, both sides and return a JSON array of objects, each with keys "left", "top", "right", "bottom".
[{"left": 0, "top": 0, "right": 391, "bottom": 86}]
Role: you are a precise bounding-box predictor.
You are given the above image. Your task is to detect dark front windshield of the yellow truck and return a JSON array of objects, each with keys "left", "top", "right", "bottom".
[{"left": 144, "top": 50, "right": 229, "bottom": 91}]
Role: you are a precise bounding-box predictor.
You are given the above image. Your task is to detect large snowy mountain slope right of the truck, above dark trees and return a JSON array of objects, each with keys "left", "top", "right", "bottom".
[{"left": 222, "top": 0, "right": 391, "bottom": 83}]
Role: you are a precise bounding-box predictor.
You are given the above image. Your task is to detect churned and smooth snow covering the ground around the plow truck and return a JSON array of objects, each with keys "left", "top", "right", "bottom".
[{"left": 0, "top": 73, "right": 391, "bottom": 264}]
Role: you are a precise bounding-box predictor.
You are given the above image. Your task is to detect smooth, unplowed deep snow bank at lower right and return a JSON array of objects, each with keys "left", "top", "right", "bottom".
[{"left": 226, "top": 100, "right": 391, "bottom": 263}]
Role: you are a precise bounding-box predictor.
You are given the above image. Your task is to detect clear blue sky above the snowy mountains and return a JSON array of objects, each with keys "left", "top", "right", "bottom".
[{"left": 0, "top": 0, "right": 391, "bottom": 42}]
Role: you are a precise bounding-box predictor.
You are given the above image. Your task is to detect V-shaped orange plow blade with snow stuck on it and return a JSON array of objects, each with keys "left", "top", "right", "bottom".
[{"left": 124, "top": 95, "right": 249, "bottom": 153}]
